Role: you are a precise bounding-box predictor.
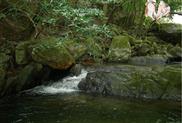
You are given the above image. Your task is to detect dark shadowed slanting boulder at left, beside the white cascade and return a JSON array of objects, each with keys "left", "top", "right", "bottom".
[{"left": 0, "top": 63, "right": 43, "bottom": 96}]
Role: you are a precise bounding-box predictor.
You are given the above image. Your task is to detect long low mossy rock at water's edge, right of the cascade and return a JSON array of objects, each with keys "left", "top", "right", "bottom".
[{"left": 78, "top": 65, "right": 181, "bottom": 100}]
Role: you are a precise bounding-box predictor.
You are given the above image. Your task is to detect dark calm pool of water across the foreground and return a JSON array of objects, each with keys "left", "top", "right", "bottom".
[{"left": 0, "top": 93, "right": 181, "bottom": 123}]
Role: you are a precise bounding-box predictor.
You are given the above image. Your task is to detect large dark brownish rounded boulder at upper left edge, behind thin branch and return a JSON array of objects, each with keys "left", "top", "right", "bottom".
[{"left": 0, "top": 11, "right": 35, "bottom": 41}]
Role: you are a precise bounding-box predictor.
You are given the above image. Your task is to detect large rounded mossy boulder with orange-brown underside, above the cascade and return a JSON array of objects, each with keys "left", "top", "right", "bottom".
[{"left": 32, "top": 38, "right": 75, "bottom": 70}]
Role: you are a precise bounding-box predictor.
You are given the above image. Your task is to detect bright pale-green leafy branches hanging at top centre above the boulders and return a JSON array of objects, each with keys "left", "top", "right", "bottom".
[{"left": 33, "top": 0, "right": 111, "bottom": 37}]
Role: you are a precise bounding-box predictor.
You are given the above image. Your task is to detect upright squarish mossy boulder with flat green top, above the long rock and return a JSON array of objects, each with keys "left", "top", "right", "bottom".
[{"left": 108, "top": 36, "right": 131, "bottom": 62}]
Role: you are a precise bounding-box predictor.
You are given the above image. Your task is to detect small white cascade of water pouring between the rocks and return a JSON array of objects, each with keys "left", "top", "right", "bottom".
[{"left": 31, "top": 70, "right": 87, "bottom": 94}]
